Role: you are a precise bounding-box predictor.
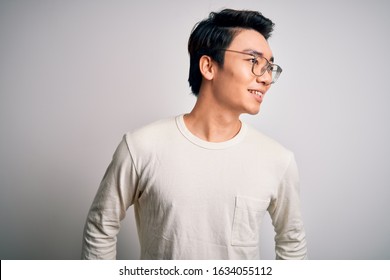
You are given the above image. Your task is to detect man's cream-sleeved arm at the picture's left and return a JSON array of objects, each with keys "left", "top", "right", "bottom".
[{"left": 81, "top": 139, "right": 138, "bottom": 259}]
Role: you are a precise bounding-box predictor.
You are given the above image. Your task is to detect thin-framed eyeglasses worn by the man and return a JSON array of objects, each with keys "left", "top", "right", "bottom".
[{"left": 222, "top": 49, "right": 282, "bottom": 84}]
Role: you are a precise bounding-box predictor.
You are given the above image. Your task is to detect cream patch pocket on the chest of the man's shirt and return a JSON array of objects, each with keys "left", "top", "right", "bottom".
[{"left": 231, "top": 196, "right": 269, "bottom": 246}]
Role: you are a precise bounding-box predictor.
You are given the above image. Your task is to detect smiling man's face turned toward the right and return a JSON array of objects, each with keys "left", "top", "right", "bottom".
[{"left": 212, "top": 30, "right": 273, "bottom": 115}]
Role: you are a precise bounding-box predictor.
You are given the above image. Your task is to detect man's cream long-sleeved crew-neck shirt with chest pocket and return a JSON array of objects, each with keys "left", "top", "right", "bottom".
[{"left": 82, "top": 115, "right": 306, "bottom": 259}]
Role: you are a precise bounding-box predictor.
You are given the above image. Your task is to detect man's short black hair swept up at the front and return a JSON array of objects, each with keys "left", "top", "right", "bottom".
[{"left": 188, "top": 9, "right": 274, "bottom": 96}]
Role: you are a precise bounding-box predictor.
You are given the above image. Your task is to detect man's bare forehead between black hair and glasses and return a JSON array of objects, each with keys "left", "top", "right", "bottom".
[{"left": 229, "top": 29, "right": 272, "bottom": 58}]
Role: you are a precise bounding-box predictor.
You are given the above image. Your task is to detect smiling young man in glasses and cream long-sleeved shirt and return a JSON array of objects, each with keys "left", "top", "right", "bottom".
[{"left": 82, "top": 9, "right": 306, "bottom": 259}]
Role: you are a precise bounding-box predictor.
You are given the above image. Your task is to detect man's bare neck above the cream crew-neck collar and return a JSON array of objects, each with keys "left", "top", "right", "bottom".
[{"left": 184, "top": 93, "right": 241, "bottom": 142}]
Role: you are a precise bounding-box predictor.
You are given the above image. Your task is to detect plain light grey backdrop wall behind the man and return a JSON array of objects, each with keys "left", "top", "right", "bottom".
[{"left": 0, "top": 0, "right": 390, "bottom": 259}]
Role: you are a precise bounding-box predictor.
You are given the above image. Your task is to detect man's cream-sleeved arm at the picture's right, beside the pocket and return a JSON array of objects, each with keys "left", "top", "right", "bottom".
[{"left": 268, "top": 155, "right": 307, "bottom": 259}]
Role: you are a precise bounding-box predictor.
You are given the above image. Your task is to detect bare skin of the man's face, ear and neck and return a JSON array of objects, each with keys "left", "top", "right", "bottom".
[{"left": 184, "top": 30, "right": 273, "bottom": 142}]
